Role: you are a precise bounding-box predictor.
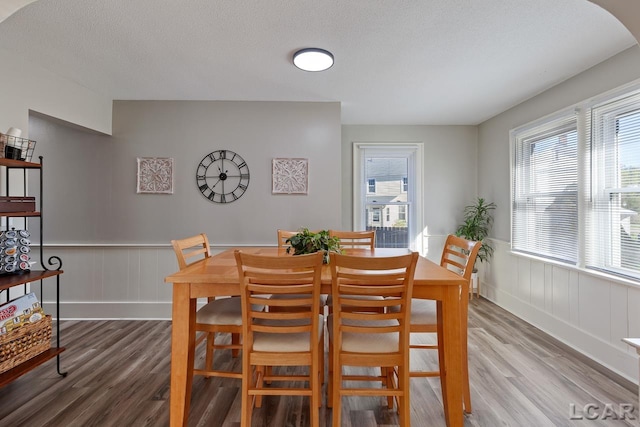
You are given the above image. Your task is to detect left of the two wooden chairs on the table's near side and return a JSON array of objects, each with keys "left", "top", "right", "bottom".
[{"left": 235, "top": 250, "right": 324, "bottom": 427}]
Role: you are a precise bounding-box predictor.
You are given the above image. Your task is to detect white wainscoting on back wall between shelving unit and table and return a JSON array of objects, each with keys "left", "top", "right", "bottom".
[{"left": 28, "top": 244, "right": 235, "bottom": 319}]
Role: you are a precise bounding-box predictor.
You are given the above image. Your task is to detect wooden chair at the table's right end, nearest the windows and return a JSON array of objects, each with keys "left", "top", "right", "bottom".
[{"left": 392, "top": 235, "right": 481, "bottom": 413}]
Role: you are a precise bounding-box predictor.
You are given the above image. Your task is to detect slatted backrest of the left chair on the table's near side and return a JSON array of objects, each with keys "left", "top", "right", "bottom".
[{"left": 235, "top": 250, "right": 324, "bottom": 351}]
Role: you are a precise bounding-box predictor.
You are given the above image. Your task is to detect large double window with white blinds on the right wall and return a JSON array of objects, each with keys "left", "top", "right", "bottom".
[{"left": 511, "top": 86, "right": 640, "bottom": 279}]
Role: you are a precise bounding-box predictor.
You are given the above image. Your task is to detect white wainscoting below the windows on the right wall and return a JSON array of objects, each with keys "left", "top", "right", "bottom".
[{"left": 480, "top": 240, "right": 640, "bottom": 383}]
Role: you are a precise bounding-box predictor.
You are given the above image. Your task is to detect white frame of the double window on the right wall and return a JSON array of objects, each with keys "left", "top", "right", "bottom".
[{"left": 509, "top": 79, "right": 640, "bottom": 284}]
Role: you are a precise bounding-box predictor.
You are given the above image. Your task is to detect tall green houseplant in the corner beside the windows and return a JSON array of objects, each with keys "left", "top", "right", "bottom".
[{"left": 456, "top": 197, "right": 496, "bottom": 271}]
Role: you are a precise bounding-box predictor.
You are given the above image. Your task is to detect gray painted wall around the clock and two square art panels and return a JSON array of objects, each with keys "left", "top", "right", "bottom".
[{"left": 30, "top": 101, "right": 342, "bottom": 244}]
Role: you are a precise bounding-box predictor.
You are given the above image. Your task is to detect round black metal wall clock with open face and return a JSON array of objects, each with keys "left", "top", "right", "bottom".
[{"left": 196, "top": 150, "right": 249, "bottom": 203}]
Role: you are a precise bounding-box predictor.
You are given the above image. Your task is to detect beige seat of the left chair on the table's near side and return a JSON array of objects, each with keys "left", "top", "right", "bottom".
[{"left": 253, "top": 315, "right": 324, "bottom": 353}]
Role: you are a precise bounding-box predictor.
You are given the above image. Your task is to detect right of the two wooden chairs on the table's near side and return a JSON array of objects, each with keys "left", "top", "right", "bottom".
[{"left": 327, "top": 252, "right": 418, "bottom": 427}]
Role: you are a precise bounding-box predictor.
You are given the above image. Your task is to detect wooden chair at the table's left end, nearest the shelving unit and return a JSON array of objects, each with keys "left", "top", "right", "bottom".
[{"left": 171, "top": 233, "right": 242, "bottom": 378}]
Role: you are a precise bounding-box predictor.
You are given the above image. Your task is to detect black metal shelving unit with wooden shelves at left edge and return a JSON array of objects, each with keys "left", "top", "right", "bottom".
[{"left": 0, "top": 156, "right": 67, "bottom": 387}]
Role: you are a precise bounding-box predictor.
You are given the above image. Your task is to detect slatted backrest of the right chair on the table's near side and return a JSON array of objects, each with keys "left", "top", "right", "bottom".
[{"left": 329, "top": 252, "right": 418, "bottom": 353}]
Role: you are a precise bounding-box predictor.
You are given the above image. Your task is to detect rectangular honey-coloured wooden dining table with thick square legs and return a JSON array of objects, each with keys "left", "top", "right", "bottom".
[{"left": 164, "top": 247, "right": 468, "bottom": 427}]
